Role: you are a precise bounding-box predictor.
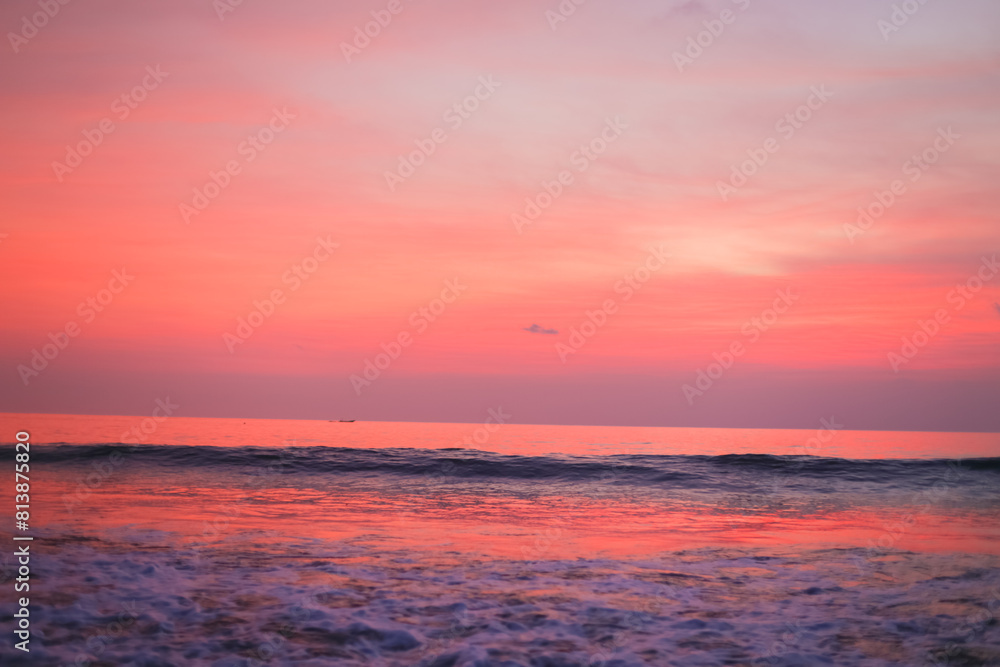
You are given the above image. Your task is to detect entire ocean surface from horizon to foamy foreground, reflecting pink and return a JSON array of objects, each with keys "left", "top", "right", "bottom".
[{"left": 0, "top": 410, "right": 1000, "bottom": 667}]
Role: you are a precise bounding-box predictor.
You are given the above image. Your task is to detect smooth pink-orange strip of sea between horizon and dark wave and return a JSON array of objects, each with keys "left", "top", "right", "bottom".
[{"left": 0, "top": 413, "right": 1000, "bottom": 459}]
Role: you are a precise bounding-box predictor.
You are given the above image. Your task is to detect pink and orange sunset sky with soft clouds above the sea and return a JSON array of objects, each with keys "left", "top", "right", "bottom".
[{"left": 0, "top": 0, "right": 1000, "bottom": 431}]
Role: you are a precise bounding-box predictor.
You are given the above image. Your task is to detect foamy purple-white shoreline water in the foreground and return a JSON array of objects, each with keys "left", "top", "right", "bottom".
[{"left": 0, "top": 539, "right": 1000, "bottom": 667}]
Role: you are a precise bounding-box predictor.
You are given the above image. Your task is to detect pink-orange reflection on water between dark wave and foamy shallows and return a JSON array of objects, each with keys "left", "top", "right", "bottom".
[{"left": 34, "top": 470, "right": 1000, "bottom": 560}]
